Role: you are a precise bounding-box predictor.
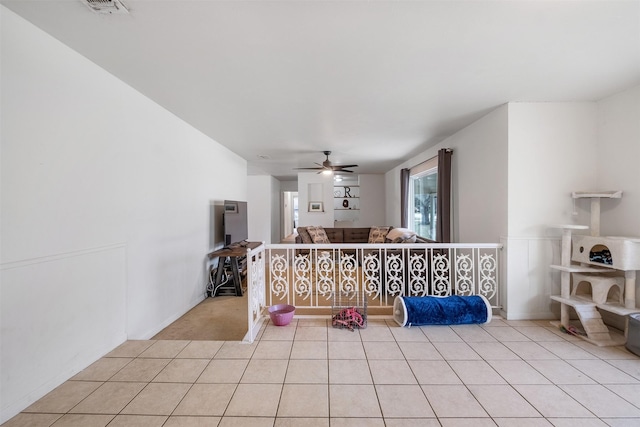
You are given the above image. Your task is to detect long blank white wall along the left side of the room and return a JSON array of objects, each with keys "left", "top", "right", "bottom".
[{"left": 0, "top": 6, "right": 247, "bottom": 422}]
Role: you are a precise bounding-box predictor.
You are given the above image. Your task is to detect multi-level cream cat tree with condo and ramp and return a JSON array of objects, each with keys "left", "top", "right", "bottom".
[{"left": 551, "top": 191, "right": 640, "bottom": 346}]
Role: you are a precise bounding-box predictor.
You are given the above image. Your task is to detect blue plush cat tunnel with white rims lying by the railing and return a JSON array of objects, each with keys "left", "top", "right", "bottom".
[{"left": 393, "top": 295, "right": 491, "bottom": 326}]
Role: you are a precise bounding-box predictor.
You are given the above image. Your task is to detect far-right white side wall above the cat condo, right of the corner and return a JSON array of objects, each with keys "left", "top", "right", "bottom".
[{"left": 586, "top": 86, "right": 640, "bottom": 237}]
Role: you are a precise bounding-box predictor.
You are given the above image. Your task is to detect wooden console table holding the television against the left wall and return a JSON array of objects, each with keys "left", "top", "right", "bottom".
[{"left": 207, "top": 242, "right": 262, "bottom": 297}]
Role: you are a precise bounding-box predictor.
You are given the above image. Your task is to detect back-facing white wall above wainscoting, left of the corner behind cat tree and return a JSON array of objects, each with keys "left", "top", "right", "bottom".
[{"left": 508, "top": 102, "right": 598, "bottom": 236}]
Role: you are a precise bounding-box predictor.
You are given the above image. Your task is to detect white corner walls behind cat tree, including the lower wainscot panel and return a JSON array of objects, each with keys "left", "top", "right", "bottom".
[{"left": 507, "top": 94, "right": 640, "bottom": 319}]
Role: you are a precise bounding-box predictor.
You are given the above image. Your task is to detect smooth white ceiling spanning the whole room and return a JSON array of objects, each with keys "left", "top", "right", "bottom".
[{"left": 0, "top": 0, "right": 640, "bottom": 178}]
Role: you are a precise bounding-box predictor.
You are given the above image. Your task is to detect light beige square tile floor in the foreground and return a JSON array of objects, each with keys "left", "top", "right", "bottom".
[{"left": 4, "top": 319, "right": 640, "bottom": 427}]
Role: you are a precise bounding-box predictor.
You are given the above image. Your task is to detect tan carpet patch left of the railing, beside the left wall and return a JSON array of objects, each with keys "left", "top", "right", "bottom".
[{"left": 153, "top": 296, "right": 247, "bottom": 341}]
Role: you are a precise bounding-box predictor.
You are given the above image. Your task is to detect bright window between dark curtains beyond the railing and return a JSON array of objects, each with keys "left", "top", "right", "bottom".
[{"left": 408, "top": 157, "right": 438, "bottom": 240}]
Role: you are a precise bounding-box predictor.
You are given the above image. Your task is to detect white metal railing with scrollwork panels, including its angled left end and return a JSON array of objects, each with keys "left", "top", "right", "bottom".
[{"left": 245, "top": 243, "right": 502, "bottom": 341}]
